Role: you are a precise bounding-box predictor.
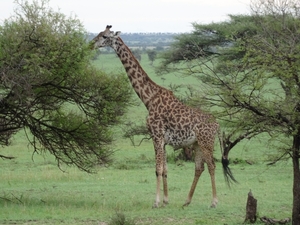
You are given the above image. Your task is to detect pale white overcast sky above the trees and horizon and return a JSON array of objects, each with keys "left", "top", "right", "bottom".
[{"left": 0, "top": 0, "right": 251, "bottom": 33}]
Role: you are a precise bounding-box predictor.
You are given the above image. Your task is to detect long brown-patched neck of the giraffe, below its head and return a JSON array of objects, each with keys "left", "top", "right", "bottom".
[{"left": 112, "top": 38, "right": 164, "bottom": 108}]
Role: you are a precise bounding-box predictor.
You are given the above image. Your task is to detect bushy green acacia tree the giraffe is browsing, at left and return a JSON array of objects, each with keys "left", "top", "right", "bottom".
[{"left": 0, "top": 0, "right": 131, "bottom": 172}]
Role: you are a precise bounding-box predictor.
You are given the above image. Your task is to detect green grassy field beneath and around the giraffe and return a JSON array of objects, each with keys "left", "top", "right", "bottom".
[{"left": 0, "top": 54, "right": 292, "bottom": 225}]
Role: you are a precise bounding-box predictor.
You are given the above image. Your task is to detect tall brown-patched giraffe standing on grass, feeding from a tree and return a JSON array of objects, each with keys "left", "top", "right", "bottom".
[{"left": 91, "top": 25, "right": 226, "bottom": 208}]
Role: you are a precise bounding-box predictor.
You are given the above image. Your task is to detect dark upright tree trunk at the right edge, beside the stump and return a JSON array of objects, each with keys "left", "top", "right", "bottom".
[{"left": 292, "top": 135, "right": 300, "bottom": 225}]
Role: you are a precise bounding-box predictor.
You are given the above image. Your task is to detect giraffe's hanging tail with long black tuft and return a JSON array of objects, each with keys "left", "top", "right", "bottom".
[{"left": 218, "top": 129, "right": 238, "bottom": 187}]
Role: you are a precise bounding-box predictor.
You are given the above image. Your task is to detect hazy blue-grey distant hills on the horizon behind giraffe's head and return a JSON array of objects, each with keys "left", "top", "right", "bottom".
[{"left": 89, "top": 33, "right": 179, "bottom": 48}]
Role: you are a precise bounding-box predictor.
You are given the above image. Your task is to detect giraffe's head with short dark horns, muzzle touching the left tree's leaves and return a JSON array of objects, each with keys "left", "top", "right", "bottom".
[{"left": 92, "top": 25, "right": 121, "bottom": 49}]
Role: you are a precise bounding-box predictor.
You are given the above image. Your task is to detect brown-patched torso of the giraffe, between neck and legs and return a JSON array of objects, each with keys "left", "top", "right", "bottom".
[{"left": 147, "top": 90, "right": 219, "bottom": 149}]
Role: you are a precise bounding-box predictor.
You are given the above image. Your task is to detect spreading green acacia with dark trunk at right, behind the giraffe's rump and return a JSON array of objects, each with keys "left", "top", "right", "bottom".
[{"left": 162, "top": 0, "right": 300, "bottom": 224}]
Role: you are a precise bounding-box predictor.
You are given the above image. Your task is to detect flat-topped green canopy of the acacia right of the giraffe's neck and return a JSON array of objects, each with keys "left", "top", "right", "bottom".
[{"left": 160, "top": 15, "right": 259, "bottom": 74}]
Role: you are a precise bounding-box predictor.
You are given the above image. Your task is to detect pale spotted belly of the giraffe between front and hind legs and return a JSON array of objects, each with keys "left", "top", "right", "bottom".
[{"left": 165, "top": 130, "right": 197, "bottom": 148}]
